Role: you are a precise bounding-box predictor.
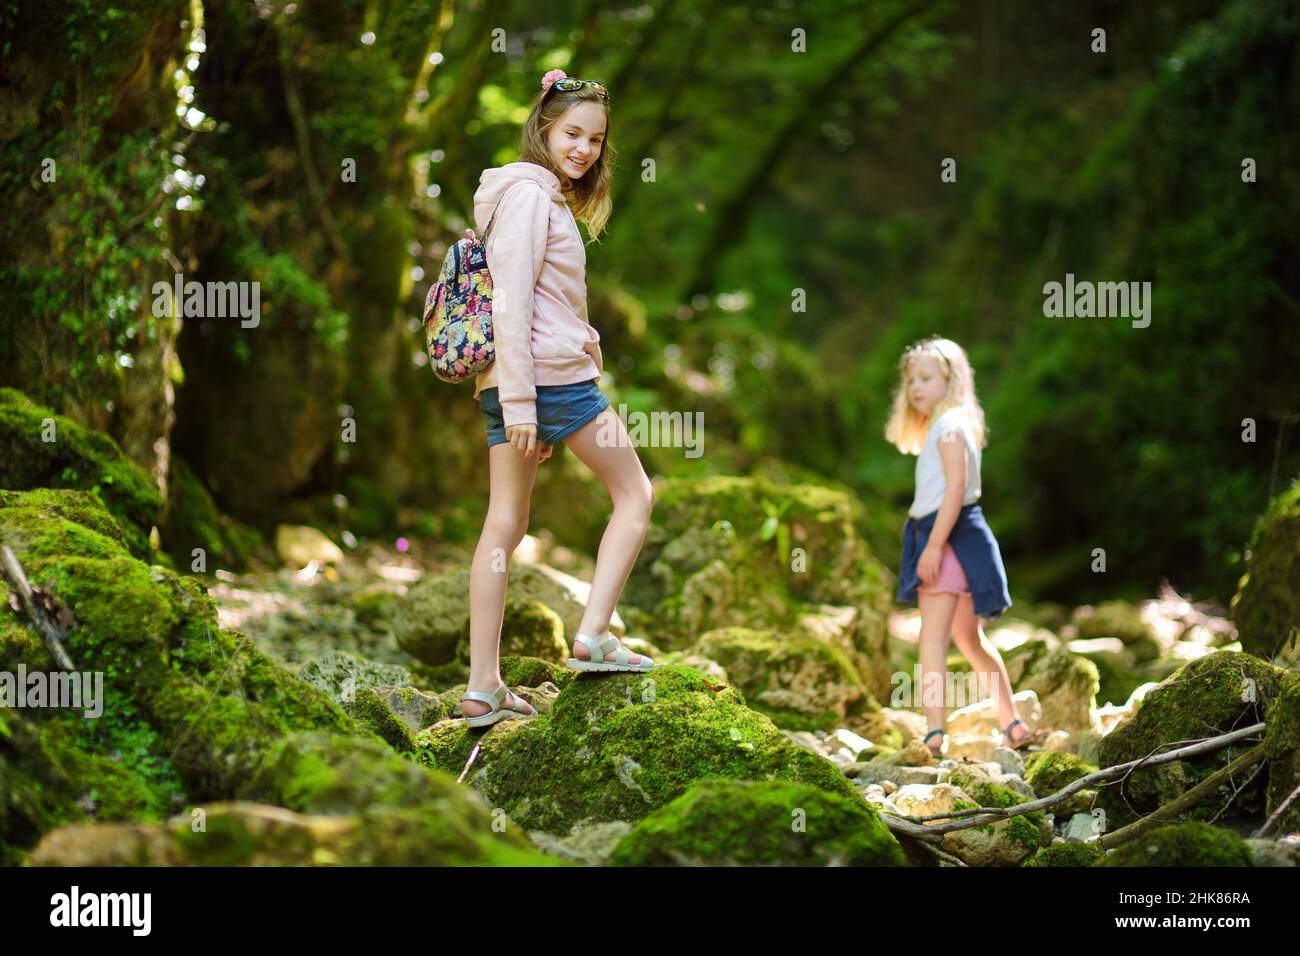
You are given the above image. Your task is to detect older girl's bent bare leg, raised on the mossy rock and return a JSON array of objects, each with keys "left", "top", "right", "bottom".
[{"left": 564, "top": 407, "right": 654, "bottom": 663}]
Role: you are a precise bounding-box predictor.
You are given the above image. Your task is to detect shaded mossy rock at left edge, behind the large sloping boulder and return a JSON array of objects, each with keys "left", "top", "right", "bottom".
[{"left": 0, "top": 388, "right": 163, "bottom": 559}]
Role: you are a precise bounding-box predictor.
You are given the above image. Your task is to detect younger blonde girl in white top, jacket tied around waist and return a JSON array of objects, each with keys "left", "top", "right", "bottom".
[{"left": 885, "top": 336, "right": 1043, "bottom": 754}]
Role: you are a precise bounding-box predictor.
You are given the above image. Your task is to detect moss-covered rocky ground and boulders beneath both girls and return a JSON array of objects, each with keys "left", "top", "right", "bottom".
[{"left": 0, "top": 385, "right": 1300, "bottom": 866}]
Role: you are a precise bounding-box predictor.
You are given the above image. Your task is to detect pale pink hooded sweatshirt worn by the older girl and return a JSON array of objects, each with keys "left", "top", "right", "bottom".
[{"left": 475, "top": 163, "right": 605, "bottom": 425}]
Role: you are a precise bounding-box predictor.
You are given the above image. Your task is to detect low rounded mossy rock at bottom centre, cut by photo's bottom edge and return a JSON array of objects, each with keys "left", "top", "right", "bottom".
[{"left": 610, "top": 780, "right": 905, "bottom": 866}]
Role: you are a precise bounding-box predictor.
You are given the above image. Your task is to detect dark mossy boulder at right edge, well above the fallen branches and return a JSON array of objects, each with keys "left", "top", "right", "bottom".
[{"left": 1231, "top": 479, "right": 1300, "bottom": 661}]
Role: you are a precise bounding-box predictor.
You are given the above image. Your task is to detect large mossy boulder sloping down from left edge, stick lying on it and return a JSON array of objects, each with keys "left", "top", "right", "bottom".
[{"left": 0, "top": 489, "right": 553, "bottom": 862}]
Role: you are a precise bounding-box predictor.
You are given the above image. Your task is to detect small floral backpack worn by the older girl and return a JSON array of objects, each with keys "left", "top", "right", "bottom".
[{"left": 424, "top": 188, "right": 506, "bottom": 385}]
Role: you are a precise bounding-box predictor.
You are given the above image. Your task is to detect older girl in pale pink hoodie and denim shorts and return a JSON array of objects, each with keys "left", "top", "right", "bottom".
[{"left": 460, "top": 70, "right": 658, "bottom": 727}]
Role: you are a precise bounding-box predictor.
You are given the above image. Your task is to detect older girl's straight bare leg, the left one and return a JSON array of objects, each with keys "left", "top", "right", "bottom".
[{"left": 460, "top": 442, "right": 537, "bottom": 717}]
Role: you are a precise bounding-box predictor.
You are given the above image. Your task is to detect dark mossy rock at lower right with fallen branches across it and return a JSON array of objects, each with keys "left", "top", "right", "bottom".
[{"left": 1099, "top": 650, "right": 1283, "bottom": 830}]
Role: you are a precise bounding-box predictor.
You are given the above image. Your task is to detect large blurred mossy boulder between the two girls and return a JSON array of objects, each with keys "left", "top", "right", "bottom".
[{"left": 624, "top": 475, "right": 893, "bottom": 700}]
